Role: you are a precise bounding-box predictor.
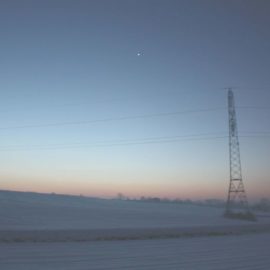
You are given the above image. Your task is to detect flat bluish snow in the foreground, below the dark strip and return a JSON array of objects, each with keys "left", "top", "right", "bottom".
[{"left": 0, "top": 234, "right": 270, "bottom": 270}]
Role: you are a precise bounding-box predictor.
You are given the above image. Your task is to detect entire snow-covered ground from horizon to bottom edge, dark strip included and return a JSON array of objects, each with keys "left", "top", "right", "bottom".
[{"left": 0, "top": 191, "right": 270, "bottom": 270}]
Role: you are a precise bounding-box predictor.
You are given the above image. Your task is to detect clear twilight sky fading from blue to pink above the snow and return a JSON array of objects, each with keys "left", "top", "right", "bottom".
[{"left": 0, "top": 0, "right": 270, "bottom": 199}]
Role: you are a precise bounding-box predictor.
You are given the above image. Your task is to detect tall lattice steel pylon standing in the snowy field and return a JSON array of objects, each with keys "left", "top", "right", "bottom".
[{"left": 225, "top": 88, "right": 250, "bottom": 217}]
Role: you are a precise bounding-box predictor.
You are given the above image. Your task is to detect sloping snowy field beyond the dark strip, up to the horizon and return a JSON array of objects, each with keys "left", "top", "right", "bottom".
[{"left": 0, "top": 191, "right": 270, "bottom": 230}]
